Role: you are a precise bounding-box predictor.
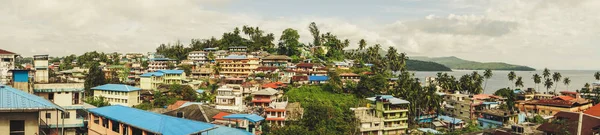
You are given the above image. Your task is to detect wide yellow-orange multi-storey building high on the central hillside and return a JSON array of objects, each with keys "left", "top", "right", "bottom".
[{"left": 217, "top": 55, "right": 260, "bottom": 77}]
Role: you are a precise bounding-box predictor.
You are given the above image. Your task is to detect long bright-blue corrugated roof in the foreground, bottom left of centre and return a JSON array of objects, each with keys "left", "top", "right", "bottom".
[{"left": 90, "top": 105, "right": 251, "bottom": 135}]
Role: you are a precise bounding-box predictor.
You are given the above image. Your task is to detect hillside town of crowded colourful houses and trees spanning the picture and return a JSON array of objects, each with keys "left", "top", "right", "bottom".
[{"left": 0, "top": 41, "right": 600, "bottom": 135}]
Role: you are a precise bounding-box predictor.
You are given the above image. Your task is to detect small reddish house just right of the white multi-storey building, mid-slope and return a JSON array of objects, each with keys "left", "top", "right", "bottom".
[{"left": 252, "top": 88, "right": 285, "bottom": 108}]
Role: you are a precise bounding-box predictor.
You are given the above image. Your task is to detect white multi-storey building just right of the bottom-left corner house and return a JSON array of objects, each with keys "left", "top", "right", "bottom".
[{"left": 33, "top": 83, "right": 87, "bottom": 135}]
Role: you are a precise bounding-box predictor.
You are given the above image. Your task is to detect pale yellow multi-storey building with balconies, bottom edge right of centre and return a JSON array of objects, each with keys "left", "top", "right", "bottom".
[{"left": 351, "top": 95, "right": 410, "bottom": 135}]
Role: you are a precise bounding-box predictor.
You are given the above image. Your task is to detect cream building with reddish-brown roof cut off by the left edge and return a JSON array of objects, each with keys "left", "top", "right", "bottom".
[{"left": 0, "top": 49, "right": 18, "bottom": 84}]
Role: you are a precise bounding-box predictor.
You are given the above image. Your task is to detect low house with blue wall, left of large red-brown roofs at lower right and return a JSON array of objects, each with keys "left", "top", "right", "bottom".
[{"left": 477, "top": 109, "right": 525, "bottom": 129}]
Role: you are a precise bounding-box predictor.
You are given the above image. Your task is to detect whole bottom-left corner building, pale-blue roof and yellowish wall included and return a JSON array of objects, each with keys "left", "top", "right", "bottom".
[{"left": 0, "top": 85, "right": 65, "bottom": 135}]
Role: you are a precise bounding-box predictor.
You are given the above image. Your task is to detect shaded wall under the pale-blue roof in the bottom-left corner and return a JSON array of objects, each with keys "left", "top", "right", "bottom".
[{"left": 0, "top": 112, "right": 39, "bottom": 135}]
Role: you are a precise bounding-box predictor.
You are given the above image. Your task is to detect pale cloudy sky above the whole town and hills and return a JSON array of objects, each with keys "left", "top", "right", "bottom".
[{"left": 0, "top": 0, "right": 600, "bottom": 70}]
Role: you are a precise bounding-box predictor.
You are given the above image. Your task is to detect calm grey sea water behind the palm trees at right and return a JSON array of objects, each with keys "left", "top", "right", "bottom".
[{"left": 413, "top": 70, "right": 597, "bottom": 94}]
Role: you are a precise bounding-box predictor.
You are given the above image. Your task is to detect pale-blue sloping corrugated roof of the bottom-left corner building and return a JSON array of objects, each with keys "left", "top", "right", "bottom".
[{"left": 0, "top": 85, "right": 64, "bottom": 111}]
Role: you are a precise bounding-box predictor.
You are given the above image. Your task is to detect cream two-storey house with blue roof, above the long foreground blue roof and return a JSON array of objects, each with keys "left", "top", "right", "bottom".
[{"left": 91, "top": 84, "right": 142, "bottom": 107}]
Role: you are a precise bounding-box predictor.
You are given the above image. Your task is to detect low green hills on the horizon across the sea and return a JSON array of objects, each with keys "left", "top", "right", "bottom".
[{"left": 410, "top": 56, "right": 535, "bottom": 71}]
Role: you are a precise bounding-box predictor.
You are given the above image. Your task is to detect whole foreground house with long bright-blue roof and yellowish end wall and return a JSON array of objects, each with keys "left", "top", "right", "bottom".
[{"left": 88, "top": 105, "right": 251, "bottom": 135}]
